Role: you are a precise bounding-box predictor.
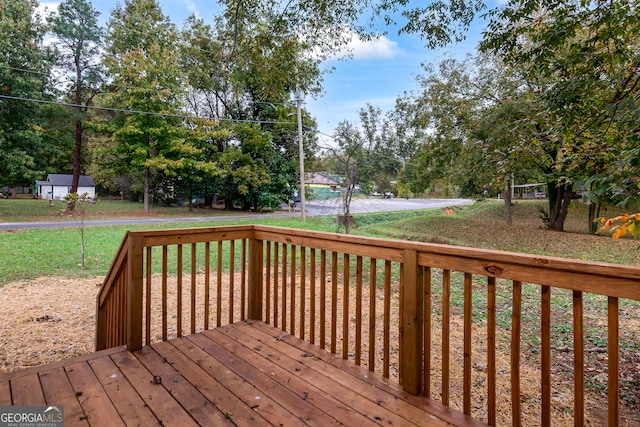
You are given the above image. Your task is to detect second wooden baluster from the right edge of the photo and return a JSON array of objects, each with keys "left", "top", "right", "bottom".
[{"left": 573, "top": 291, "right": 584, "bottom": 427}]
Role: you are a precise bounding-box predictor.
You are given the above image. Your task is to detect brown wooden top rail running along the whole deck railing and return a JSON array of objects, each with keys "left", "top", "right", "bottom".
[{"left": 101, "top": 225, "right": 640, "bottom": 300}]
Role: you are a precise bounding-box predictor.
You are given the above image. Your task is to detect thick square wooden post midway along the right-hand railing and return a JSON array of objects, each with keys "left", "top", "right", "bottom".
[{"left": 400, "top": 249, "right": 424, "bottom": 394}]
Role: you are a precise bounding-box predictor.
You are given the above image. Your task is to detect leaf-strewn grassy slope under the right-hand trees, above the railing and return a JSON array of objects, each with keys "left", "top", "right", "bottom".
[{"left": 361, "top": 201, "right": 640, "bottom": 265}]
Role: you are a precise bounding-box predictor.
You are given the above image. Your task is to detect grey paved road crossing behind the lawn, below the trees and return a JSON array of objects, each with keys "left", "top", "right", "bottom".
[{"left": 0, "top": 198, "right": 473, "bottom": 230}]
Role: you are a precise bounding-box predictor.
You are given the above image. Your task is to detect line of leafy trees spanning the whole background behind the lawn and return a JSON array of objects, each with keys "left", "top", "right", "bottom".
[{"left": 0, "top": 0, "right": 640, "bottom": 231}]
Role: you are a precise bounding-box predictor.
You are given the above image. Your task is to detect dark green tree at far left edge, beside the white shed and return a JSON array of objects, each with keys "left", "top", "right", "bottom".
[{"left": 0, "top": 0, "right": 50, "bottom": 186}]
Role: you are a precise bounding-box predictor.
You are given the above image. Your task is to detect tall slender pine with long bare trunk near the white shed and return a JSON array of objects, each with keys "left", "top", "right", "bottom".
[{"left": 48, "top": 0, "right": 103, "bottom": 211}]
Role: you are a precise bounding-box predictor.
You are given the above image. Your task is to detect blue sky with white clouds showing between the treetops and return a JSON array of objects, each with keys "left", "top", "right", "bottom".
[{"left": 41, "top": 0, "right": 490, "bottom": 134}]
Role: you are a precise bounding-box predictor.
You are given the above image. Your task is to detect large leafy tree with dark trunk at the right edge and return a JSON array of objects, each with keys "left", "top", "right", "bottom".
[{"left": 482, "top": 0, "right": 640, "bottom": 231}]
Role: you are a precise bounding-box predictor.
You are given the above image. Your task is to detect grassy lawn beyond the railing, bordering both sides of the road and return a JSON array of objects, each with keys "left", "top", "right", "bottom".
[{"left": 0, "top": 199, "right": 640, "bottom": 285}]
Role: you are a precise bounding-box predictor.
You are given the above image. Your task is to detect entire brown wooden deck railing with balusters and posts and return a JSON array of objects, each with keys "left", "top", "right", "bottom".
[{"left": 96, "top": 225, "right": 640, "bottom": 426}]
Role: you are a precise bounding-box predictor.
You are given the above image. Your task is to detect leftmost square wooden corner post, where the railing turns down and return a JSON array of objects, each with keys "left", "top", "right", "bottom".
[{"left": 126, "top": 236, "right": 144, "bottom": 351}]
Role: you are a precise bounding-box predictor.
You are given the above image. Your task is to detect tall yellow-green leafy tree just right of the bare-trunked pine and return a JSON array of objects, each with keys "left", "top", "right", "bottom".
[{"left": 105, "top": 0, "right": 186, "bottom": 212}]
